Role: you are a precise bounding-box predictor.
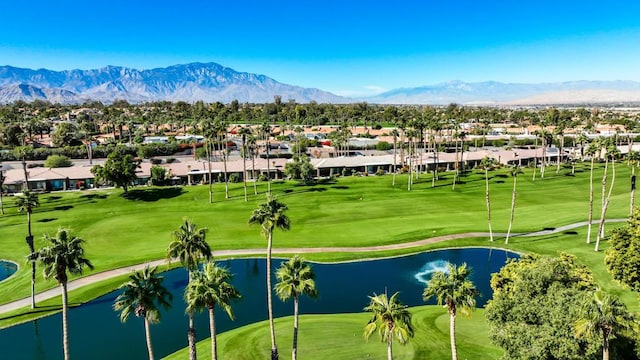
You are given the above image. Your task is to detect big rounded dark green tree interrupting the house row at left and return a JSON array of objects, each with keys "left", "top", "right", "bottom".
[{"left": 91, "top": 152, "right": 140, "bottom": 193}]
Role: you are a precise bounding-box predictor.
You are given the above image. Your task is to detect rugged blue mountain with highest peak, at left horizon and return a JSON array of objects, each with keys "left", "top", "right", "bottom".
[{"left": 0, "top": 63, "right": 351, "bottom": 104}]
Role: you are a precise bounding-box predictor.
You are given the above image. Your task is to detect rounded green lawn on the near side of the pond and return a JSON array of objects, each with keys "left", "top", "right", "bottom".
[{"left": 165, "top": 306, "right": 502, "bottom": 360}]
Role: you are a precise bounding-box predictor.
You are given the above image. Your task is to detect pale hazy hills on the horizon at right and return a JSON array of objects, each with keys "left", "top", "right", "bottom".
[{"left": 364, "top": 81, "right": 640, "bottom": 105}]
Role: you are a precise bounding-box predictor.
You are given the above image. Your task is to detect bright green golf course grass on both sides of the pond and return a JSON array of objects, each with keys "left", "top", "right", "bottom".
[{"left": 0, "top": 165, "right": 640, "bottom": 359}]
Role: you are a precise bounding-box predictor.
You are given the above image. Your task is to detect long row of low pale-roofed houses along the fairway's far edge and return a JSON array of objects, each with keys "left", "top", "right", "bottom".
[{"left": 0, "top": 148, "right": 568, "bottom": 193}]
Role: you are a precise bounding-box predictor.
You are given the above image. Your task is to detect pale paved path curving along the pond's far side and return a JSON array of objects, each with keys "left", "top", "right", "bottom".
[{"left": 0, "top": 219, "right": 627, "bottom": 315}]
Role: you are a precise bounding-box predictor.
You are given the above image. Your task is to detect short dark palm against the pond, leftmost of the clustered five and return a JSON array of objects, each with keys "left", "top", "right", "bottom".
[{"left": 113, "top": 267, "right": 173, "bottom": 360}]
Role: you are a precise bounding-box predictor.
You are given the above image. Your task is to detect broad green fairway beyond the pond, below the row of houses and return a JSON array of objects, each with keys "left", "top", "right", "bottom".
[{"left": 0, "top": 164, "right": 629, "bottom": 320}]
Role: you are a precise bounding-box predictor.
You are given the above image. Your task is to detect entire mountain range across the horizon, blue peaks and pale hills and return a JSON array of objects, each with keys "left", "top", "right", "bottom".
[{"left": 0, "top": 63, "right": 640, "bottom": 105}]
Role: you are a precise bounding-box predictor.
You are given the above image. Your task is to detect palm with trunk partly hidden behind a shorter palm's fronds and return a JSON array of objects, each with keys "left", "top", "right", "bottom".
[{"left": 167, "top": 219, "right": 212, "bottom": 360}]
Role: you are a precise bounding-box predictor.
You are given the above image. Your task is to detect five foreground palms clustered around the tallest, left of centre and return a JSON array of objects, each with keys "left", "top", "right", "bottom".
[{"left": 113, "top": 197, "right": 318, "bottom": 359}]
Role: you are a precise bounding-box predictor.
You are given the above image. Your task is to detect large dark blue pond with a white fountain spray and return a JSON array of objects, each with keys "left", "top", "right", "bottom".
[{"left": 0, "top": 248, "right": 518, "bottom": 360}]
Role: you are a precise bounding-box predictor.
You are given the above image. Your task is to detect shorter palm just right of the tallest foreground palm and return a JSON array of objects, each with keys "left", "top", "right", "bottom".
[{"left": 276, "top": 255, "right": 318, "bottom": 360}]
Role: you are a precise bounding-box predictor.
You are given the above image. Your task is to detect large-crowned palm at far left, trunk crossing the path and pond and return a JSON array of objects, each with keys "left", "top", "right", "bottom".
[{"left": 29, "top": 228, "right": 93, "bottom": 360}]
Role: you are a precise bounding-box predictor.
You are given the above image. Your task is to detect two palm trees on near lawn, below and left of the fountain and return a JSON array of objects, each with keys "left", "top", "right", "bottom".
[{"left": 364, "top": 263, "right": 480, "bottom": 360}]
